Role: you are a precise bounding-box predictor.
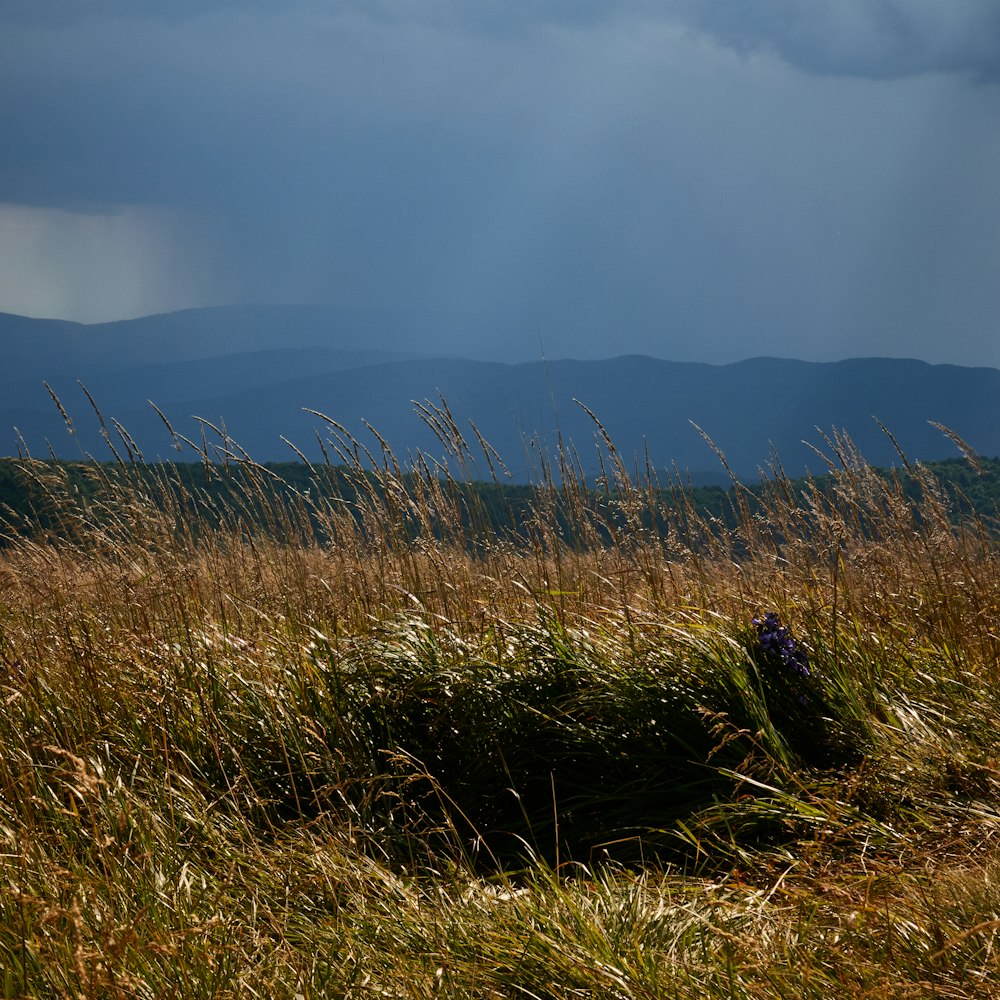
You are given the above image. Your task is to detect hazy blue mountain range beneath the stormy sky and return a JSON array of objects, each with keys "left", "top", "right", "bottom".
[{"left": 0, "top": 306, "right": 1000, "bottom": 482}]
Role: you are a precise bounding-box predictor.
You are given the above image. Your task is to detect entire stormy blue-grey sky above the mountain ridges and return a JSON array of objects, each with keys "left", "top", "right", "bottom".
[{"left": 0, "top": 0, "right": 1000, "bottom": 367}]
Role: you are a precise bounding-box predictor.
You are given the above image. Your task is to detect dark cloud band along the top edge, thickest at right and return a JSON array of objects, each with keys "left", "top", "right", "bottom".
[{"left": 0, "top": 0, "right": 1000, "bottom": 80}]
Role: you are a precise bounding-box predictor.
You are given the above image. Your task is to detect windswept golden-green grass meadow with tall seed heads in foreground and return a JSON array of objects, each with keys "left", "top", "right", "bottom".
[{"left": 0, "top": 405, "right": 1000, "bottom": 1000}]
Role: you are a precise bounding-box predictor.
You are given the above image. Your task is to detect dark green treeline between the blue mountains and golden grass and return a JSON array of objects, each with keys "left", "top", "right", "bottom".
[{"left": 0, "top": 458, "right": 1000, "bottom": 541}]
